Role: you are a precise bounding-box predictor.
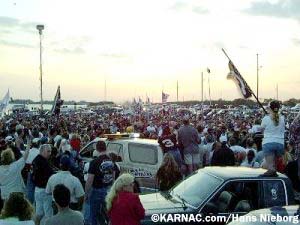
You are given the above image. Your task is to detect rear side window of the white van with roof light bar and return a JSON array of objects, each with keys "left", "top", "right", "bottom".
[{"left": 128, "top": 143, "right": 158, "bottom": 165}]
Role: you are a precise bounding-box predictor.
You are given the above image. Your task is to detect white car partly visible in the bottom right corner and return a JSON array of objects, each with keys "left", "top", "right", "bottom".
[{"left": 229, "top": 205, "right": 300, "bottom": 225}]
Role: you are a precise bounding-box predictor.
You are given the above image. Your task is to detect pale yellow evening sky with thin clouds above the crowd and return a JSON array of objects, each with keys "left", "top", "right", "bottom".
[{"left": 0, "top": 0, "right": 300, "bottom": 103}]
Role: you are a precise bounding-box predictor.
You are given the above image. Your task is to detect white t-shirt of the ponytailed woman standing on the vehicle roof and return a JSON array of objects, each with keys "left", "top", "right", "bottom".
[{"left": 261, "top": 115, "right": 285, "bottom": 144}]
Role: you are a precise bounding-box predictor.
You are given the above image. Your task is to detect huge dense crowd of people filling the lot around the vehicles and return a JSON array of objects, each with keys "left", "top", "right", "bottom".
[{"left": 0, "top": 101, "right": 300, "bottom": 225}]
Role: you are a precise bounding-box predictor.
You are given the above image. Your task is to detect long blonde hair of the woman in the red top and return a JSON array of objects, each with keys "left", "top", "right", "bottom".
[{"left": 105, "top": 173, "right": 134, "bottom": 211}]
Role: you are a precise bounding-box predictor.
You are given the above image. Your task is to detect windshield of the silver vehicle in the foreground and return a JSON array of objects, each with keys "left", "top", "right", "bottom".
[{"left": 170, "top": 170, "right": 223, "bottom": 208}]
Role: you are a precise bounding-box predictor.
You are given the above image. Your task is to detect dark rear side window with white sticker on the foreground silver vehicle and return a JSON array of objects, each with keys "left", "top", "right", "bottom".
[{"left": 263, "top": 180, "right": 286, "bottom": 208}]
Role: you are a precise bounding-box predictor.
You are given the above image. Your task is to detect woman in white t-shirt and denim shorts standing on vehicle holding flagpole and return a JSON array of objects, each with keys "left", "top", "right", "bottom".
[{"left": 261, "top": 100, "right": 285, "bottom": 175}]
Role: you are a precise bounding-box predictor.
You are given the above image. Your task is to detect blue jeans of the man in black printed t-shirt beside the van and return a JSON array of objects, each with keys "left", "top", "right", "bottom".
[{"left": 89, "top": 188, "right": 108, "bottom": 225}]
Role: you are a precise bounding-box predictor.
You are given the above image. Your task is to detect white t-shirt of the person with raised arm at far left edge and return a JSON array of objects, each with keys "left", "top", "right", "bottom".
[{"left": 0, "top": 157, "right": 25, "bottom": 199}]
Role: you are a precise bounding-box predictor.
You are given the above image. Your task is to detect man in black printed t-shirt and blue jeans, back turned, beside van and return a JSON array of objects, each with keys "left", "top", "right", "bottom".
[{"left": 85, "top": 141, "right": 115, "bottom": 225}]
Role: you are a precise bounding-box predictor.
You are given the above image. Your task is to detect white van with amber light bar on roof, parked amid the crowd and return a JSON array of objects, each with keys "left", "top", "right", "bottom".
[{"left": 79, "top": 134, "right": 163, "bottom": 192}]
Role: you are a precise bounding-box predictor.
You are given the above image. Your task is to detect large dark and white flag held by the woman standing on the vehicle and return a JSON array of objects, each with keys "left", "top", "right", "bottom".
[{"left": 227, "top": 60, "right": 253, "bottom": 98}]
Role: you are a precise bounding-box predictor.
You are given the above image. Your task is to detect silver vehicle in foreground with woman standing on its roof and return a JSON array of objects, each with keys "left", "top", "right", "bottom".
[{"left": 140, "top": 167, "right": 295, "bottom": 225}]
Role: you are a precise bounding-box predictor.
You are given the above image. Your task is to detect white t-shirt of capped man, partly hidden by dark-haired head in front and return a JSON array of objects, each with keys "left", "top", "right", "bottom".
[{"left": 46, "top": 171, "right": 84, "bottom": 203}]
